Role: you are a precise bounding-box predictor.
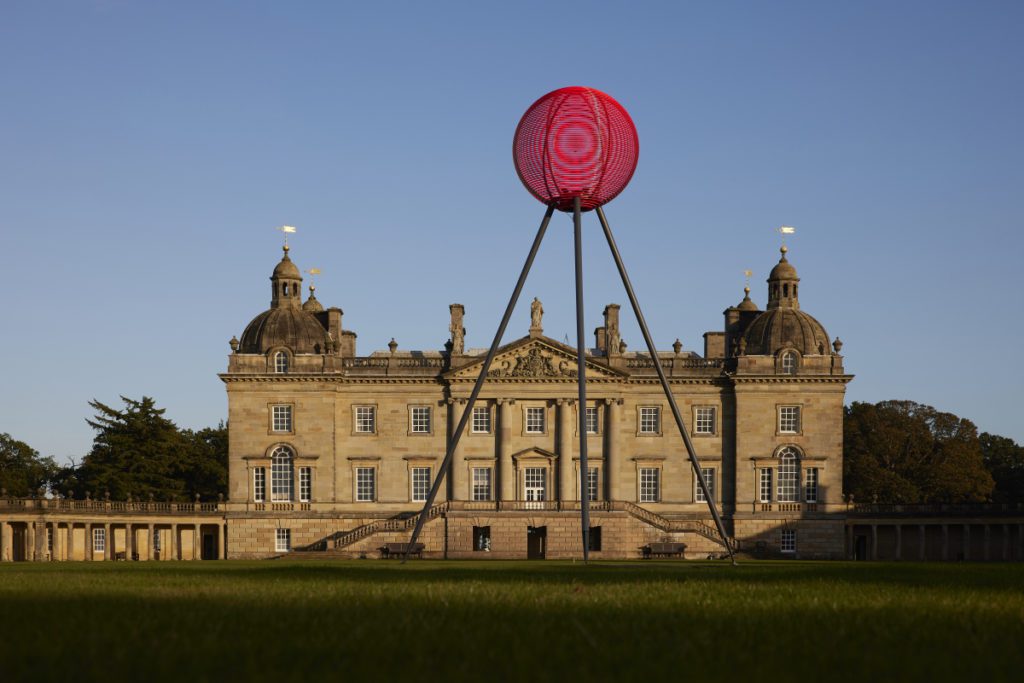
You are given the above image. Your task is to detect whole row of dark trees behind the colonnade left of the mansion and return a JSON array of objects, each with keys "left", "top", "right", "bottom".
[{"left": 0, "top": 396, "right": 227, "bottom": 501}]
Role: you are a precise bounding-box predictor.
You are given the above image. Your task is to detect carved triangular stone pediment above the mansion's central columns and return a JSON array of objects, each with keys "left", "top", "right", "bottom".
[{"left": 445, "top": 337, "right": 626, "bottom": 382}]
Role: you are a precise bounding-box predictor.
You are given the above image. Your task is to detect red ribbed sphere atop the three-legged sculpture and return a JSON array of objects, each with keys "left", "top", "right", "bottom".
[{"left": 512, "top": 86, "right": 640, "bottom": 211}]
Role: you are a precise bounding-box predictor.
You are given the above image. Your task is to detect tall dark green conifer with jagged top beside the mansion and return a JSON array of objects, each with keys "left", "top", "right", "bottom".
[{"left": 73, "top": 396, "right": 227, "bottom": 501}]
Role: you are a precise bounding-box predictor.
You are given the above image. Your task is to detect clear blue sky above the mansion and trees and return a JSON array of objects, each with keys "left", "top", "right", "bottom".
[{"left": 0, "top": 0, "right": 1024, "bottom": 459}]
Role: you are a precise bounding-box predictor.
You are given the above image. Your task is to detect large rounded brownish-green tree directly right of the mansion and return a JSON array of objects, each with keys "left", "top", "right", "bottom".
[{"left": 843, "top": 400, "right": 994, "bottom": 503}]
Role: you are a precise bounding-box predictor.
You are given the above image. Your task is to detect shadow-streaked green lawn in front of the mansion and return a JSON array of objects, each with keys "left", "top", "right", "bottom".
[{"left": 0, "top": 561, "right": 1024, "bottom": 683}]
